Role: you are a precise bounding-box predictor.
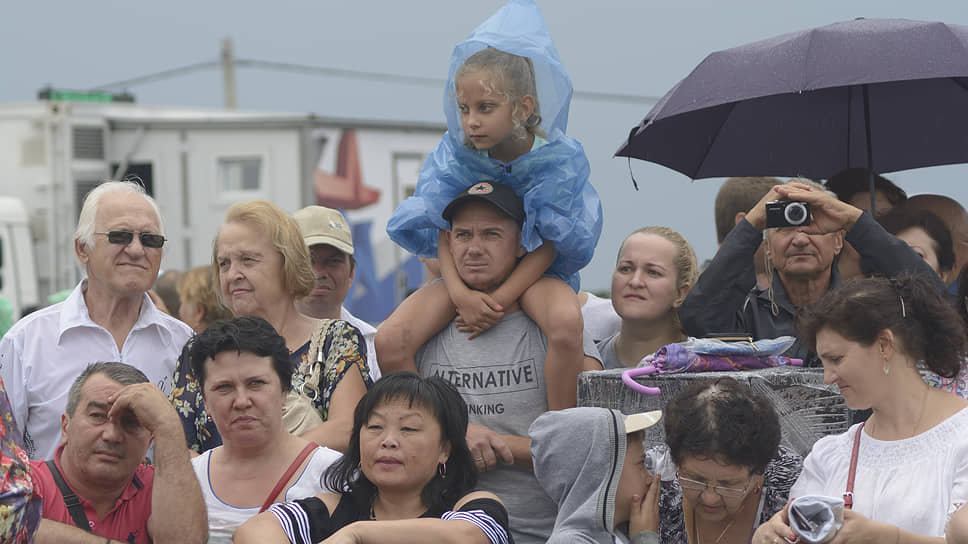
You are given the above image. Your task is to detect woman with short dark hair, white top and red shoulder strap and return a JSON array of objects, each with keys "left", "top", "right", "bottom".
[{"left": 186, "top": 316, "right": 341, "bottom": 544}]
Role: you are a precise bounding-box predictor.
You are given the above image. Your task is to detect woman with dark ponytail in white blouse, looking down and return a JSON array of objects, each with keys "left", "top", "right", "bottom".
[{"left": 753, "top": 276, "right": 968, "bottom": 544}]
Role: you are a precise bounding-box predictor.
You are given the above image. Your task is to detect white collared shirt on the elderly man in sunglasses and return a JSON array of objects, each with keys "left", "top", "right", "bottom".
[{"left": 0, "top": 280, "right": 192, "bottom": 459}]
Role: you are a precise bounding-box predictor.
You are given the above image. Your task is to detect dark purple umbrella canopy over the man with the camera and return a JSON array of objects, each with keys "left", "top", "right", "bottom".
[{"left": 616, "top": 19, "right": 968, "bottom": 179}]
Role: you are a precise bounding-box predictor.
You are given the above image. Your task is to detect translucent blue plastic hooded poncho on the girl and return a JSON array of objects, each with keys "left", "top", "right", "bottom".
[{"left": 387, "top": 0, "right": 602, "bottom": 291}]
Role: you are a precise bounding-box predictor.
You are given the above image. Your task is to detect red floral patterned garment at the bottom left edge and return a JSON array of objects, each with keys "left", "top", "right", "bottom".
[{"left": 0, "top": 380, "right": 42, "bottom": 544}]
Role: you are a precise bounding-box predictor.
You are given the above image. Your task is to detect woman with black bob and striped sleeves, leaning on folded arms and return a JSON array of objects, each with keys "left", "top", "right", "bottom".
[{"left": 234, "top": 372, "right": 510, "bottom": 544}]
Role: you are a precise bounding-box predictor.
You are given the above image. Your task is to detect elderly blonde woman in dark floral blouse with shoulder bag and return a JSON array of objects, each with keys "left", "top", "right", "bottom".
[{"left": 171, "top": 200, "right": 372, "bottom": 453}]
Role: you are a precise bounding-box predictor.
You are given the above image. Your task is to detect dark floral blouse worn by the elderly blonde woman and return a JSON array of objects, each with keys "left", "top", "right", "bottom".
[{"left": 170, "top": 319, "right": 373, "bottom": 453}]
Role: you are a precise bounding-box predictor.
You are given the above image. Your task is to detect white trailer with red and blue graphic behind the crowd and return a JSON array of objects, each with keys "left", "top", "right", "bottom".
[{"left": 0, "top": 100, "right": 446, "bottom": 322}]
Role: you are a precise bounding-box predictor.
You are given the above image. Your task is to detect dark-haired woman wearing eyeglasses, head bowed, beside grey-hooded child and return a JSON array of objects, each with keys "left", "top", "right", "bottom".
[{"left": 641, "top": 378, "right": 801, "bottom": 544}]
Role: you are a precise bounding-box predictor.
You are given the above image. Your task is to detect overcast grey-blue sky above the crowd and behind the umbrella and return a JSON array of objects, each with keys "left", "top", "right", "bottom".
[{"left": 0, "top": 0, "right": 968, "bottom": 290}]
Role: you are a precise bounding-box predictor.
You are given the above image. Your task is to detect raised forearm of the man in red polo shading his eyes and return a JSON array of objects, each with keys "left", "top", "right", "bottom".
[{"left": 148, "top": 424, "right": 208, "bottom": 544}]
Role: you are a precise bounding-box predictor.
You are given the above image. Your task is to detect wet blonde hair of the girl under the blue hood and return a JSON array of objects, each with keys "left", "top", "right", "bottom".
[{"left": 454, "top": 47, "right": 546, "bottom": 145}]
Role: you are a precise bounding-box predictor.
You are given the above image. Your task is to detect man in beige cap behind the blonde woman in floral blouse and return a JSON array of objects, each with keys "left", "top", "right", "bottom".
[{"left": 292, "top": 206, "right": 380, "bottom": 381}]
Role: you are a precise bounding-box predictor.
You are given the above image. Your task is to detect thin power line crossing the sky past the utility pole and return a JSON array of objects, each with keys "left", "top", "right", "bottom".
[{"left": 94, "top": 59, "right": 659, "bottom": 104}]
